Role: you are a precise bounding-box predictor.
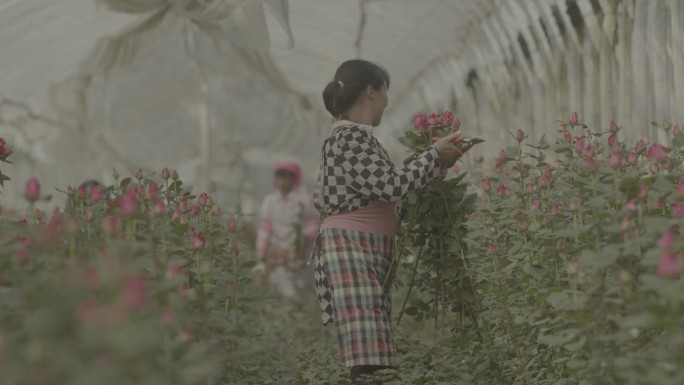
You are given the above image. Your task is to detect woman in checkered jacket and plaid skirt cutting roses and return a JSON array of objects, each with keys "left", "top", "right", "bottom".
[{"left": 314, "top": 60, "right": 461, "bottom": 384}]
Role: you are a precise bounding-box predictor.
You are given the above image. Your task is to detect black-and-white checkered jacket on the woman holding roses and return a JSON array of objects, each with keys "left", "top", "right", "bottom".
[{"left": 314, "top": 120, "right": 440, "bottom": 217}]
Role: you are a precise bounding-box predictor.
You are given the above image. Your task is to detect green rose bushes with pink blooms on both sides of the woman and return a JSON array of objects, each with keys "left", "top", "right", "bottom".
[{"left": 0, "top": 114, "right": 684, "bottom": 385}]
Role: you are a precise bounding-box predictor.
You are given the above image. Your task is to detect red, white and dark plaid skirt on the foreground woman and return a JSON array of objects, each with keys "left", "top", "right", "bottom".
[{"left": 312, "top": 229, "right": 396, "bottom": 367}]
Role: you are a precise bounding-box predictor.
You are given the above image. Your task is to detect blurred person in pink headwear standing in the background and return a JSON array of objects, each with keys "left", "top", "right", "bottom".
[{"left": 255, "top": 161, "right": 319, "bottom": 298}]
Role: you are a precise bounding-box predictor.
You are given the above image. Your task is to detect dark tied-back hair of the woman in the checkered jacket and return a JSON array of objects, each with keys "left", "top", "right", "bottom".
[{"left": 323, "top": 59, "right": 389, "bottom": 118}]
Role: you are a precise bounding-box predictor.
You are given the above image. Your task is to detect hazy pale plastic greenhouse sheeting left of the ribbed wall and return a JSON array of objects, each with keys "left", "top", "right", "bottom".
[{"left": 0, "top": 0, "right": 495, "bottom": 210}]
